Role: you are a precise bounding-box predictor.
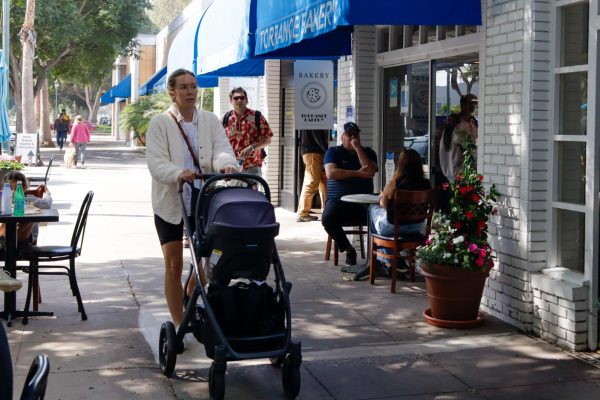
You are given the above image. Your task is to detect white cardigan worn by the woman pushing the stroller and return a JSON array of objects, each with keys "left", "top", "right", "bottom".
[{"left": 146, "top": 107, "right": 238, "bottom": 224}]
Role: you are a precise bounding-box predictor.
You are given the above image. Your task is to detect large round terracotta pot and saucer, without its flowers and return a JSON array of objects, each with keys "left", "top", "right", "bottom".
[{"left": 421, "top": 263, "right": 489, "bottom": 328}]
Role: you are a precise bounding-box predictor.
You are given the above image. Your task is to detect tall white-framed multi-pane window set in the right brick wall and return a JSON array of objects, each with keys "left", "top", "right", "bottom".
[{"left": 550, "top": 2, "right": 593, "bottom": 273}]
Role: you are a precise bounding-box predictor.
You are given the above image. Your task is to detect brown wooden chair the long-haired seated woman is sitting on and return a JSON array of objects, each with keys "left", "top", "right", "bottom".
[{"left": 369, "top": 189, "right": 436, "bottom": 293}]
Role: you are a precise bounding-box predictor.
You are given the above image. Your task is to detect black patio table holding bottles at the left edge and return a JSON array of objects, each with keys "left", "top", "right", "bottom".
[{"left": 0, "top": 207, "right": 58, "bottom": 326}]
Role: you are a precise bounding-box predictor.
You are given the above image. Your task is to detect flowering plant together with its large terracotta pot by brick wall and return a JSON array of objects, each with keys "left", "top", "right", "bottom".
[{"left": 417, "top": 142, "right": 498, "bottom": 328}]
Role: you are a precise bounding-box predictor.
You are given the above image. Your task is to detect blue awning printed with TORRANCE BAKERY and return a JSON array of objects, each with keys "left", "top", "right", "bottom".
[{"left": 254, "top": 0, "right": 481, "bottom": 58}]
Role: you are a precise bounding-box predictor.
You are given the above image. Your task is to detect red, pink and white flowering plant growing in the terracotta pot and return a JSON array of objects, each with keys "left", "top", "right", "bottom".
[{"left": 417, "top": 142, "right": 498, "bottom": 272}]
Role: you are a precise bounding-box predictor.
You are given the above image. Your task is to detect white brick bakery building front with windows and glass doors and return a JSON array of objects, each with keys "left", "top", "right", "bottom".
[{"left": 111, "top": 0, "right": 600, "bottom": 350}]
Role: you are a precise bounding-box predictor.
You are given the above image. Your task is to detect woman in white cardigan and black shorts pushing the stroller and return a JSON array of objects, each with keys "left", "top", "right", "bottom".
[{"left": 146, "top": 69, "right": 238, "bottom": 334}]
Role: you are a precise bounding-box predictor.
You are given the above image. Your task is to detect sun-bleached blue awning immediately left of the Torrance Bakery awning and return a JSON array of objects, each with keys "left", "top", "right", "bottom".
[{"left": 195, "top": 0, "right": 265, "bottom": 76}]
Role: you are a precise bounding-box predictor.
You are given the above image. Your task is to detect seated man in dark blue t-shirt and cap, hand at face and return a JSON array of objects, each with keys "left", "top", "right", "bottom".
[{"left": 322, "top": 122, "right": 377, "bottom": 265}]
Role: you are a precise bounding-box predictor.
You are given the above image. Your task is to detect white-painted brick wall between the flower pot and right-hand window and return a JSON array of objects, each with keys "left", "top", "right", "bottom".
[{"left": 479, "top": 0, "right": 576, "bottom": 350}]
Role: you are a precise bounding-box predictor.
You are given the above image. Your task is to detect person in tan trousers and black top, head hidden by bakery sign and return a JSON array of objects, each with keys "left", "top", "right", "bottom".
[{"left": 297, "top": 129, "right": 329, "bottom": 222}]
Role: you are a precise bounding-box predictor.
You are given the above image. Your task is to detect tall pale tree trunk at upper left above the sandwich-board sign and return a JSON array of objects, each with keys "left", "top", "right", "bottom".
[{"left": 19, "top": 0, "right": 36, "bottom": 133}]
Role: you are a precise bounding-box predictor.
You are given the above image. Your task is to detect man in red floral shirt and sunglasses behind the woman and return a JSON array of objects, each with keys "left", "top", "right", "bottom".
[{"left": 223, "top": 87, "right": 273, "bottom": 176}]
